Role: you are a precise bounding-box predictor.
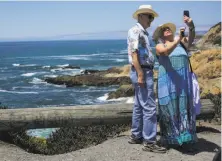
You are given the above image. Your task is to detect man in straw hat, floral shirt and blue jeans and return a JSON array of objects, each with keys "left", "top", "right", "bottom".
[{"left": 127, "top": 5, "right": 166, "bottom": 153}]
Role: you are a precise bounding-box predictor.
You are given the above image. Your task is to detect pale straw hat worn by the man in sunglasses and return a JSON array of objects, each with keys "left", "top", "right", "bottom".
[{"left": 133, "top": 5, "right": 159, "bottom": 20}]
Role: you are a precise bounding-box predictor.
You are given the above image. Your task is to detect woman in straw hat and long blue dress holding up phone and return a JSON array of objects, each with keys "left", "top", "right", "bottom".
[{"left": 153, "top": 16, "right": 197, "bottom": 146}]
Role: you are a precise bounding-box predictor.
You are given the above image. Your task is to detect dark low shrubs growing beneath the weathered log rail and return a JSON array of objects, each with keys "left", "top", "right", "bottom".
[{"left": 4, "top": 124, "right": 129, "bottom": 155}]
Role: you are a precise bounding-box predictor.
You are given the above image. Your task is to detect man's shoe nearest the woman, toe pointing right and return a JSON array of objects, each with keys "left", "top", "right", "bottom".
[{"left": 143, "top": 142, "right": 167, "bottom": 153}]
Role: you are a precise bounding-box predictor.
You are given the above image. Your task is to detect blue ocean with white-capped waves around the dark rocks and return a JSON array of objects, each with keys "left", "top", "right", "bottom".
[{"left": 0, "top": 40, "right": 139, "bottom": 137}]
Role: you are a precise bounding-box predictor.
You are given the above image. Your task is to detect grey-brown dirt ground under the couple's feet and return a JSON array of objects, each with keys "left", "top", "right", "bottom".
[{"left": 0, "top": 121, "right": 221, "bottom": 161}]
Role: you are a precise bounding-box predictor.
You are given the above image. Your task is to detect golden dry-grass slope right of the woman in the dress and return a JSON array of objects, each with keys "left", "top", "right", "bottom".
[{"left": 190, "top": 49, "right": 222, "bottom": 97}]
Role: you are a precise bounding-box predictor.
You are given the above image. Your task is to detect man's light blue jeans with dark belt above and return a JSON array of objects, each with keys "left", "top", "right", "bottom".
[{"left": 130, "top": 68, "right": 157, "bottom": 143}]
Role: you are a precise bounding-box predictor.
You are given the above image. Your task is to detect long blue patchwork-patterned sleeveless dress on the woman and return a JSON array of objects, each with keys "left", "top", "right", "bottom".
[{"left": 158, "top": 45, "right": 197, "bottom": 145}]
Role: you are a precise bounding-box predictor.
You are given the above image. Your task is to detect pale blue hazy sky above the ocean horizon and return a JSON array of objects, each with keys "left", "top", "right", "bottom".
[{"left": 0, "top": 1, "right": 221, "bottom": 40}]
